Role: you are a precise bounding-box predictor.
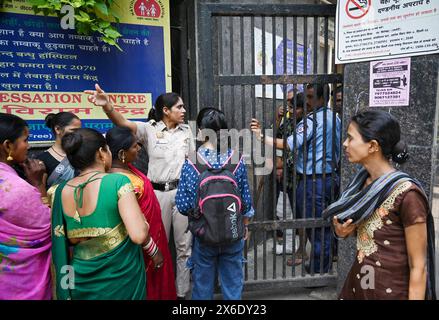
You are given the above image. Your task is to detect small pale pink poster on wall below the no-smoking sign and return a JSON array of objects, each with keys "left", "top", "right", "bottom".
[{"left": 369, "top": 58, "right": 410, "bottom": 107}]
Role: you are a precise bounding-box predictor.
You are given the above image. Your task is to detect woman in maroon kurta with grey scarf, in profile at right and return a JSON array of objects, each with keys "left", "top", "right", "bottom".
[{"left": 324, "top": 111, "right": 435, "bottom": 300}]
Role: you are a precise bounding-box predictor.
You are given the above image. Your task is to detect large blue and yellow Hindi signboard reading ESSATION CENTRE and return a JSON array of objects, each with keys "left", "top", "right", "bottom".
[{"left": 0, "top": 0, "right": 171, "bottom": 142}]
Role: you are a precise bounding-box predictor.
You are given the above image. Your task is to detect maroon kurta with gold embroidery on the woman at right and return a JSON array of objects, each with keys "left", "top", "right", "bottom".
[{"left": 340, "top": 182, "right": 429, "bottom": 300}]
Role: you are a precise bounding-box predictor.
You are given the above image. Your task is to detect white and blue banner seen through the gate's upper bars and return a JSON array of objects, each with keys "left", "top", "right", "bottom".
[{"left": 254, "top": 28, "right": 313, "bottom": 99}]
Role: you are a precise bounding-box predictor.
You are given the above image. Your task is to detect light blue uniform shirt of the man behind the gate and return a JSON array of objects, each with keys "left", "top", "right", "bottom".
[{"left": 287, "top": 107, "right": 341, "bottom": 175}]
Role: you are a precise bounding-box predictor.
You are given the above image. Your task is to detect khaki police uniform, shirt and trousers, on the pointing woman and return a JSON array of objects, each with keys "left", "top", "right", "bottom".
[{"left": 134, "top": 120, "right": 195, "bottom": 297}]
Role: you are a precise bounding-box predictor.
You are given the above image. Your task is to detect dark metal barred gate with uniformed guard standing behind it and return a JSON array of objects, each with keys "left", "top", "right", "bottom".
[{"left": 198, "top": 3, "right": 342, "bottom": 290}]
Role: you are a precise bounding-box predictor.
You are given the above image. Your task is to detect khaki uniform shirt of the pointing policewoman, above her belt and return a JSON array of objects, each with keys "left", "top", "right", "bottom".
[{"left": 134, "top": 120, "right": 195, "bottom": 183}]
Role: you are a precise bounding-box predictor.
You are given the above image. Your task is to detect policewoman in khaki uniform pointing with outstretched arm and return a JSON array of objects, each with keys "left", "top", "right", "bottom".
[{"left": 85, "top": 84, "right": 195, "bottom": 299}]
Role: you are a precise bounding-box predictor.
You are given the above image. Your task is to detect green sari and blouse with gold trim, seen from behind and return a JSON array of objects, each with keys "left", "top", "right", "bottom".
[{"left": 52, "top": 174, "right": 146, "bottom": 300}]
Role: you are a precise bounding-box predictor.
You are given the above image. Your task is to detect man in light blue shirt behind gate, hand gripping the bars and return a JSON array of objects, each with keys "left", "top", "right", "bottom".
[{"left": 251, "top": 84, "right": 341, "bottom": 273}]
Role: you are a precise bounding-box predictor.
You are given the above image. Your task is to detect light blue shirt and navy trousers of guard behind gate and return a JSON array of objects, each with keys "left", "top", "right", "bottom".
[{"left": 287, "top": 107, "right": 341, "bottom": 272}]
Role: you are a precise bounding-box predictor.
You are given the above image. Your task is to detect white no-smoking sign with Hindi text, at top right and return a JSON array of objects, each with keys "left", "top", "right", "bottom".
[{"left": 335, "top": 0, "right": 439, "bottom": 64}]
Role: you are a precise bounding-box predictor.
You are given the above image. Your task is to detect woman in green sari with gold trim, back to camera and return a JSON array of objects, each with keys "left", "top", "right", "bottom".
[{"left": 52, "top": 129, "right": 160, "bottom": 300}]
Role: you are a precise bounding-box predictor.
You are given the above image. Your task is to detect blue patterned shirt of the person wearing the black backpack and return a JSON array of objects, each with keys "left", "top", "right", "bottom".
[{"left": 175, "top": 147, "right": 255, "bottom": 218}]
